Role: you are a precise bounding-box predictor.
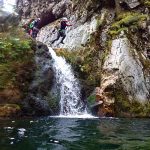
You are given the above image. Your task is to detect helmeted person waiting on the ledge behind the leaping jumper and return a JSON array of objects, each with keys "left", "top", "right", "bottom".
[{"left": 29, "top": 18, "right": 41, "bottom": 38}]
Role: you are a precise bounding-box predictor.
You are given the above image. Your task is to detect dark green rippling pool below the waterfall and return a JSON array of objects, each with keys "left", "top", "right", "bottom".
[{"left": 0, "top": 117, "right": 150, "bottom": 150}]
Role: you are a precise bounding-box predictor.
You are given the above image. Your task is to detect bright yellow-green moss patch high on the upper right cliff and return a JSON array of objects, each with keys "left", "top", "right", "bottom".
[{"left": 109, "top": 12, "right": 148, "bottom": 37}]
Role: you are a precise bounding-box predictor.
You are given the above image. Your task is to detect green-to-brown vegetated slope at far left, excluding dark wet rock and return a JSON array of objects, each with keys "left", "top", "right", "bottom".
[{"left": 0, "top": 29, "right": 35, "bottom": 111}]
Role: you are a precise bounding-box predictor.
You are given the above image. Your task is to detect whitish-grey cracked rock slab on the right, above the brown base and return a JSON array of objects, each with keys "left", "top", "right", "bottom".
[{"left": 102, "top": 38, "right": 150, "bottom": 103}]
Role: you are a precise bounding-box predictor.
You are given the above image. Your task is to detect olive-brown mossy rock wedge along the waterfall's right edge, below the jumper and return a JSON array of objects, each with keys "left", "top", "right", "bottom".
[{"left": 56, "top": 32, "right": 102, "bottom": 96}]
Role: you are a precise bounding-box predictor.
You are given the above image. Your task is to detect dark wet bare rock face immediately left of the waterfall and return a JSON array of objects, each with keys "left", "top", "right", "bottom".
[{"left": 24, "top": 42, "right": 56, "bottom": 115}]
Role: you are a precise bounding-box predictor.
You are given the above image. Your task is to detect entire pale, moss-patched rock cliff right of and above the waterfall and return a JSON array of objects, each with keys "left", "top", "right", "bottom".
[{"left": 17, "top": 0, "right": 150, "bottom": 117}]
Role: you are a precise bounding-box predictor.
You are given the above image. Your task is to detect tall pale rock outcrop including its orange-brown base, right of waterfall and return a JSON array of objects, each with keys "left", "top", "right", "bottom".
[{"left": 98, "top": 38, "right": 150, "bottom": 117}]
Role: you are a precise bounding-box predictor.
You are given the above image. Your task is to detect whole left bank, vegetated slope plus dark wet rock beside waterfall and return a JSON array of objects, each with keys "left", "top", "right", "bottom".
[{"left": 0, "top": 28, "right": 56, "bottom": 117}]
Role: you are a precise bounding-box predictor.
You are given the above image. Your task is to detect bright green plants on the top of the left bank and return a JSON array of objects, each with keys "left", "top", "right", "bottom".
[{"left": 0, "top": 31, "right": 33, "bottom": 63}]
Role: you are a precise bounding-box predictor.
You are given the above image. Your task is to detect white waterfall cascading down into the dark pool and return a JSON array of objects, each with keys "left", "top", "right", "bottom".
[{"left": 49, "top": 47, "right": 87, "bottom": 116}]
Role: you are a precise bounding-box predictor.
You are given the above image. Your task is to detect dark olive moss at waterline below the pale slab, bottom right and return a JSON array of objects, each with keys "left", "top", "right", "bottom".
[{"left": 114, "top": 89, "right": 150, "bottom": 117}]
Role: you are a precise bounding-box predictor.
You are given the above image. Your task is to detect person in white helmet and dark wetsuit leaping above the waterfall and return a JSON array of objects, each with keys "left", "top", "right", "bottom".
[{"left": 51, "top": 17, "right": 72, "bottom": 44}]
